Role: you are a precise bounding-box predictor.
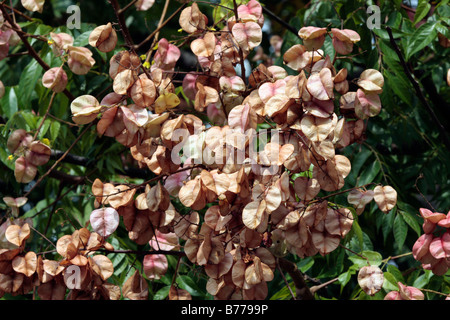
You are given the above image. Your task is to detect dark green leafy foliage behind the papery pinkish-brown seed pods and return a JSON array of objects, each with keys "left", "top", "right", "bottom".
[{"left": 0, "top": 0, "right": 450, "bottom": 299}]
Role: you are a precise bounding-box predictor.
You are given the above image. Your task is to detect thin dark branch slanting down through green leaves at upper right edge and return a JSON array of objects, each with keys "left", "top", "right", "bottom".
[{"left": 386, "top": 27, "right": 450, "bottom": 150}]
